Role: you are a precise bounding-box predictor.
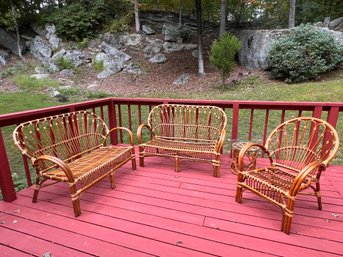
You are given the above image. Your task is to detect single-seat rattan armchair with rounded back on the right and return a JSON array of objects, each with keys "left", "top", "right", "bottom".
[{"left": 236, "top": 117, "right": 339, "bottom": 234}]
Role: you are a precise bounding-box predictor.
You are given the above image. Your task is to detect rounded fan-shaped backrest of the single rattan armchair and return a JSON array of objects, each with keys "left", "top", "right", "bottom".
[{"left": 266, "top": 117, "right": 339, "bottom": 171}]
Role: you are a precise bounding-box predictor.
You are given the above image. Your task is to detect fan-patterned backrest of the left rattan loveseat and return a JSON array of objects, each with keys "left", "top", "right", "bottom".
[{"left": 13, "top": 111, "right": 108, "bottom": 161}]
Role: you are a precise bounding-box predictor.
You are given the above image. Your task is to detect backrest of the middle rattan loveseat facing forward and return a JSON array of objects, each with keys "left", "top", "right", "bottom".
[{"left": 148, "top": 104, "right": 227, "bottom": 140}]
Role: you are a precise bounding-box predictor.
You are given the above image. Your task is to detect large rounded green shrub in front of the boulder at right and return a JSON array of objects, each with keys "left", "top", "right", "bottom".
[{"left": 267, "top": 24, "right": 343, "bottom": 83}]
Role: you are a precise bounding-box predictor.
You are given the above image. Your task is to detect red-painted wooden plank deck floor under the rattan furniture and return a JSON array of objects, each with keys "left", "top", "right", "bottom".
[{"left": 0, "top": 151, "right": 343, "bottom": 257}]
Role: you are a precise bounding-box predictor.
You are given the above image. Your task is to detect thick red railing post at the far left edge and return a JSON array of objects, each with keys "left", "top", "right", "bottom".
[{"left": 0, "top": 129, "right": 17, "bottom": 202}]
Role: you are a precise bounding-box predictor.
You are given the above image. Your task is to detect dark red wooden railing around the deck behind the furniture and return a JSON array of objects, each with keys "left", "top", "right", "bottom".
[{"left": 0, "top": 98, "right": 343, "bottom": 202}]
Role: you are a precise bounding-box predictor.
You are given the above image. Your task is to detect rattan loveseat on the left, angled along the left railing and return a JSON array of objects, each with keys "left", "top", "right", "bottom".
[{"left": 13, "top": 111, "right": 136, "bottom": 217}]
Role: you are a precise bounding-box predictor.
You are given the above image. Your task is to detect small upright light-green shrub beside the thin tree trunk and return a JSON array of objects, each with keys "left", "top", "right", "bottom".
[{"left": 209, "top": 33, "right": 241, "bottom": 85}]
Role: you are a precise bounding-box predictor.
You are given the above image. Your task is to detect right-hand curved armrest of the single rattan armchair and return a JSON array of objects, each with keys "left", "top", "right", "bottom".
[{"left": 289, "top": 161, "right": 326, "bottom": 196}]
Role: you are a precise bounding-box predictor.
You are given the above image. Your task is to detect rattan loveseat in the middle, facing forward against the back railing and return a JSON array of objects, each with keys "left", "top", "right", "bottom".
[{"left": 137, "top": 104, "right": 227, "bottom": 177}]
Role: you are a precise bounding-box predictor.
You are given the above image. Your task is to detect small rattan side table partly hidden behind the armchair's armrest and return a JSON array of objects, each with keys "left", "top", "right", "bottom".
[{"left": 231, "top": 142, "right": 258, "bottom": 175}]
